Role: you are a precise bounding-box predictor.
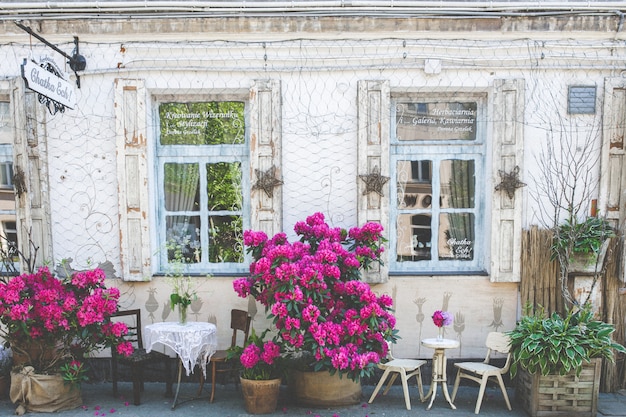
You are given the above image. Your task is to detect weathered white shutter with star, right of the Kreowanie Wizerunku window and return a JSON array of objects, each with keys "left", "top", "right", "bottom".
[{"left": 250, "top": 80, "right": 283, "bottom": 237}]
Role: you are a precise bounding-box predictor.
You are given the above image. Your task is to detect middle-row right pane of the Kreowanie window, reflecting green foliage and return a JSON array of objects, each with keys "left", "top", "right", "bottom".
[{"left": 206, "top": 162, "right": 243, "bottom": 211}]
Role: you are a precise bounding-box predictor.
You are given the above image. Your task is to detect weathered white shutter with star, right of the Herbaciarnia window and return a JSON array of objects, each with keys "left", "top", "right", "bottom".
[{"left": 490, "top": 79, "right": 524, "bottom": 282}]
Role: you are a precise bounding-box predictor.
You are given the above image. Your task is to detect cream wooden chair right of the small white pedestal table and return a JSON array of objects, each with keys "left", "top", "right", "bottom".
[{"left": 452, "top": 332, "right": 511, "bottom": 414}]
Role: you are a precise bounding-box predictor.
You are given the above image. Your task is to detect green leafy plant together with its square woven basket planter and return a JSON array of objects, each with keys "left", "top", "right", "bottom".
[{"left": 508, "top": 305, "right": 626, "bottom": 417}]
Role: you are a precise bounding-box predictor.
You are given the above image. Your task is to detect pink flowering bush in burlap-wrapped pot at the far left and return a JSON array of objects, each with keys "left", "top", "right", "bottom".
[{"left": 0, "top": 267, "right": 133, "bottom": 413}]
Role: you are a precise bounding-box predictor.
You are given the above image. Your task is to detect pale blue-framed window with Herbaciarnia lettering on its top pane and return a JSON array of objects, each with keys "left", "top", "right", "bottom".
[{"left": 389, "top": 94, "right": 488, "bottom": 274}]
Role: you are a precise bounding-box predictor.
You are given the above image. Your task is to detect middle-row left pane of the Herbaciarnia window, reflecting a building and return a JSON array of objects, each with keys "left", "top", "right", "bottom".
[{"left": 396, "top": 161, "right": 433, "bottom": 208}]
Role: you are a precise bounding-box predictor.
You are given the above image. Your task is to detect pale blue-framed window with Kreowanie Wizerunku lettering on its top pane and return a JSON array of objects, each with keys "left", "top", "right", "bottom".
[{"left": 156, "top": 96, "right": 250, "bottom": 273}]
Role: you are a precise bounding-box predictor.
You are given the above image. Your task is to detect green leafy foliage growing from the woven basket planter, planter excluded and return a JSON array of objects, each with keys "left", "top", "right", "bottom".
[{"left": 507, "top": 305, "right": 626, "bottom": 377}]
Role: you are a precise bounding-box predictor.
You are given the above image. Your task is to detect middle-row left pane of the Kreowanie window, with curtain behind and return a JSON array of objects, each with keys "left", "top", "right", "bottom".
[{"left": 163, "top": 163, "right": 200, "bottom": 211}]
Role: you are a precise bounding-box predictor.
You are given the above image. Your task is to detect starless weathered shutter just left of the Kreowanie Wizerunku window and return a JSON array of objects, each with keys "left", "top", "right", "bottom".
[{"left": 115, "top": 79, "right": 152, "bottom": 281}]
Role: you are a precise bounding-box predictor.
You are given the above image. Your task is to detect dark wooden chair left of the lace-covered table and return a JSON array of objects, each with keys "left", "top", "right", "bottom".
[{"left": 111, "top": 309, "right": 172, "bottom": 405}]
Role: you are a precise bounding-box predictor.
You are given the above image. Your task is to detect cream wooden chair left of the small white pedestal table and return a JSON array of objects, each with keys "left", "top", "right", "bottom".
[{"left": 369, "top": 344, "right": 426, "bottom": 410}]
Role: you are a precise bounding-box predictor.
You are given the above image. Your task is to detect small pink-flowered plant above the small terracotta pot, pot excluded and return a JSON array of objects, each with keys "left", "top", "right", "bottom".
[{"left": 228, "top": 329, "right": 285, "bottom": 381}]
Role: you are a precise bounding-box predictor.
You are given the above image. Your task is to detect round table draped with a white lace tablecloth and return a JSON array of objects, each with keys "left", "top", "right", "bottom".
[{"left": 144, "top": 321, "right": 217, "bottom": 410}]
